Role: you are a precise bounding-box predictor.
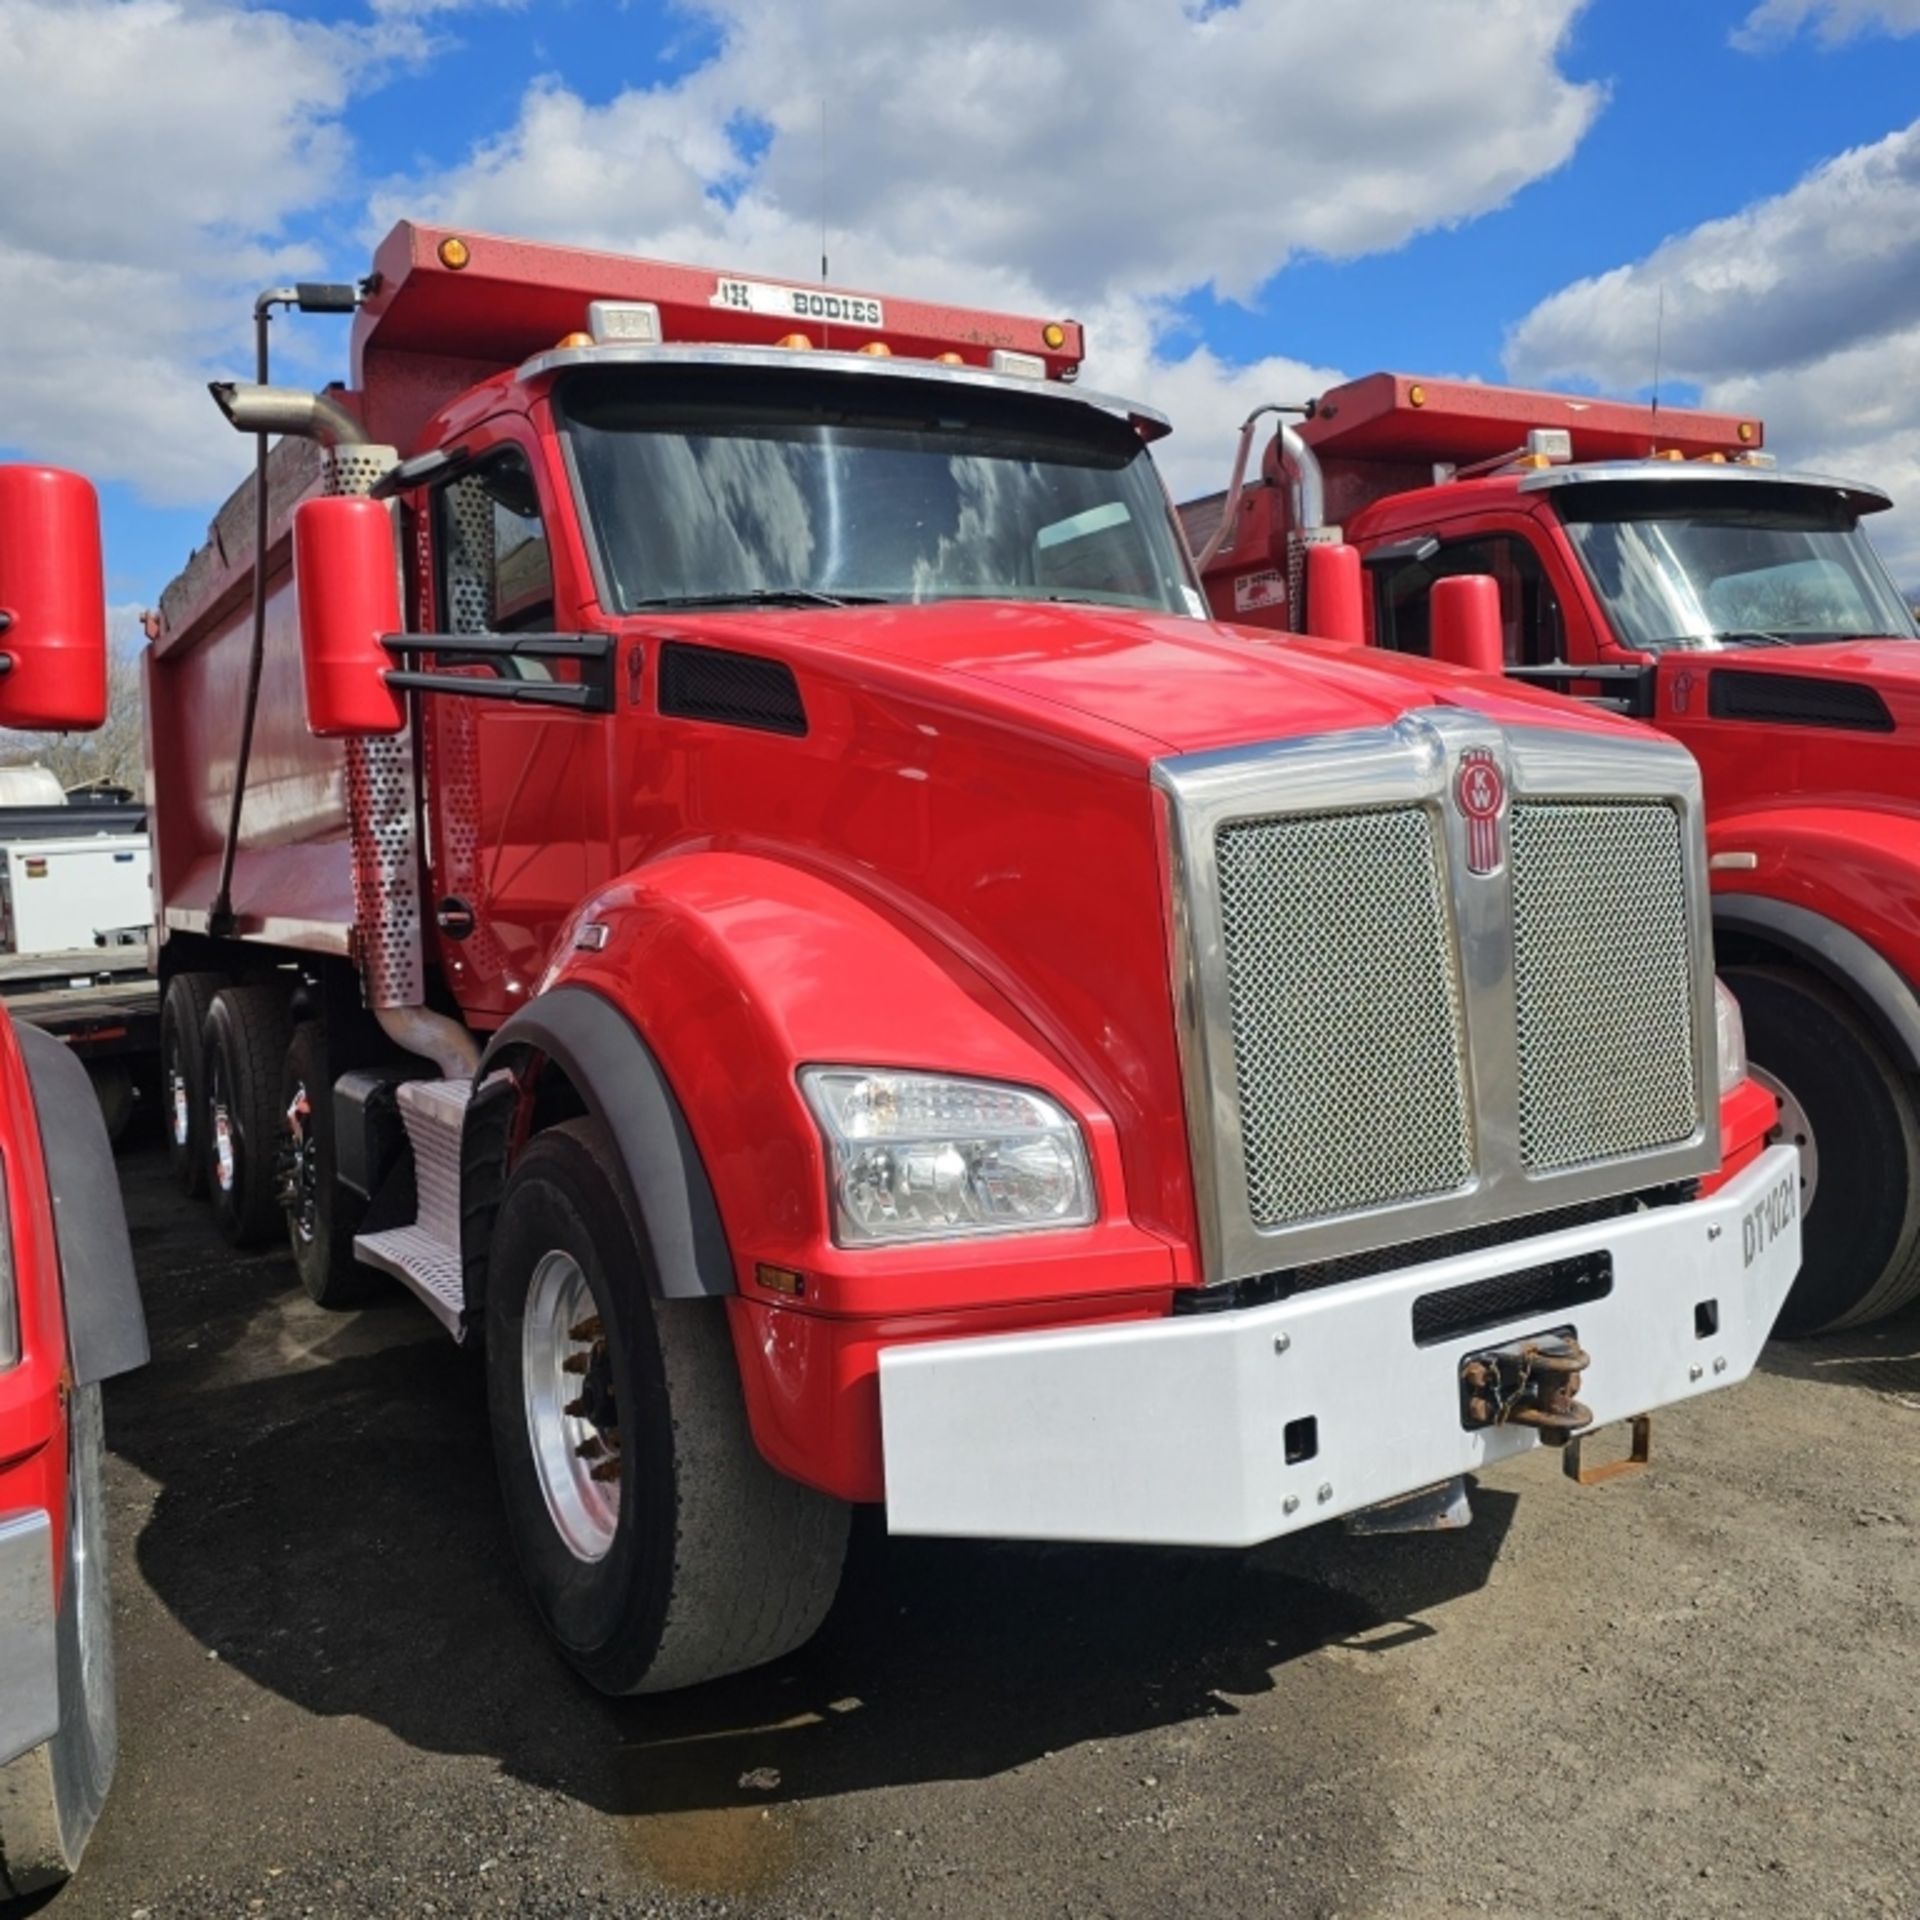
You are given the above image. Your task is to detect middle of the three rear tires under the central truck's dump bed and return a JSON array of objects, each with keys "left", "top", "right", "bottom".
[{"left": 202, "top": 981, "right": 292, "bottom": 1246}]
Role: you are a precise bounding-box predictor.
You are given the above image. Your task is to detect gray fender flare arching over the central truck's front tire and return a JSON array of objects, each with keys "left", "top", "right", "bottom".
[{"left": 461, "top": 987, "right": 735, "bottom": 1329}]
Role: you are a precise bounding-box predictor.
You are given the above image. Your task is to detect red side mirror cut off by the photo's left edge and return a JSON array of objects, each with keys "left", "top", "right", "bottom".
[{"left": 0, "top": 467, "right": 108, "bottom": 733}]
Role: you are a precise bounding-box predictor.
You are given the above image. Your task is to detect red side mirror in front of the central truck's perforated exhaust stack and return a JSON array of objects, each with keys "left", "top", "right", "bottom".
[{"left": 294, "top": 495, "right": 407, "bottom": 739}]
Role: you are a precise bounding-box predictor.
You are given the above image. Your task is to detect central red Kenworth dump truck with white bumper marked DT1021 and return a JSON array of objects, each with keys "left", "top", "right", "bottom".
[{"left": 135, "top": 225, "right": 1799, "bottom": 1692}]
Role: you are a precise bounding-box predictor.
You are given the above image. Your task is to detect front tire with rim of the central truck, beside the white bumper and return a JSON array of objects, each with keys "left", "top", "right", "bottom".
[{"left": 486, "top": 1119, "right": 847, "bottom": 1693}]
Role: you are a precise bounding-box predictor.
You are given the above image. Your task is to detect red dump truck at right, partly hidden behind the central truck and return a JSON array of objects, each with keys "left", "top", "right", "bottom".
[{"left": 1183, "top": 372, "right": 1920, "bottom": 1334}]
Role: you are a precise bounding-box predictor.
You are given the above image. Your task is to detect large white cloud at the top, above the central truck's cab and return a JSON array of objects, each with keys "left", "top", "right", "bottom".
[{"left": 380, "top": 0, "right": 1601, "bottom": 303}]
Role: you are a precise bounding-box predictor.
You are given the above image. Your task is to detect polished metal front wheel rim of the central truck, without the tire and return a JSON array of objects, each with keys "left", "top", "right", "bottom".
[{"left": 520, "top": 1248, "right": 620, "bottom": 1561}]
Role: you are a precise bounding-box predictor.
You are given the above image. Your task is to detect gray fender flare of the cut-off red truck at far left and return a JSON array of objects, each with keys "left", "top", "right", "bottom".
[{"left": 13, "top": 1023, "right": 148, "bottom": 1386}]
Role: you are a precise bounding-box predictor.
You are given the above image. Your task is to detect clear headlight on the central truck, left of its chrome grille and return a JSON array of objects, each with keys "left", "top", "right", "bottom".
[{"left": 801, "top": 1068, "right": 1092, "bottom": 1246}]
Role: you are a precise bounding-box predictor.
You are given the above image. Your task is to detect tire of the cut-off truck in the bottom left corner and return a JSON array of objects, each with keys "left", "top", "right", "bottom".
[{"left": 0, "top": 1386, "right": 119, "bottom": 1897}]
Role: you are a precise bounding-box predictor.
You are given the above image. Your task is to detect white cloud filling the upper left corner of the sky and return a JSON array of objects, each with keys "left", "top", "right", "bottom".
[{"left": 0, "top": 0, "right": 422, "bottom": 503}]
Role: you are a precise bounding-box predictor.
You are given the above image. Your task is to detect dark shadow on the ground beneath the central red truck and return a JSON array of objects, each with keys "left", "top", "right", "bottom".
[{"left": 108, "top": 1156, "right": 1513, "bottom": 1818}]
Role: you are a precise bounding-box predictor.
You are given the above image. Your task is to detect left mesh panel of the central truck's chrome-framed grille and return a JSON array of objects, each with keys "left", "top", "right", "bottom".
[{"left": 1215, "top": 806, "right": 1473, "bottom": 1227}]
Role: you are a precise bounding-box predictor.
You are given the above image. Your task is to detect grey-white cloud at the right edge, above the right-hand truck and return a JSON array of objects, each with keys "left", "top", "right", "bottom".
[{"left": 1505, "top": 121, "right": 1920, "bottom": 580}]
